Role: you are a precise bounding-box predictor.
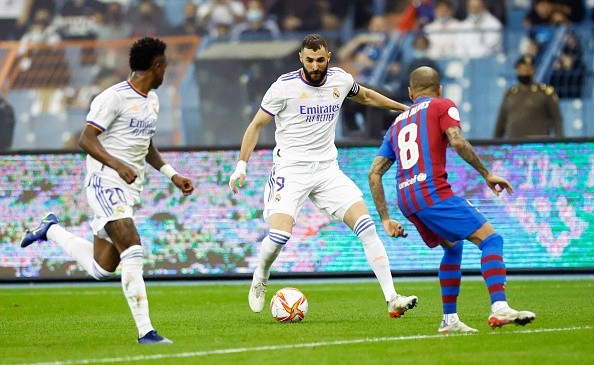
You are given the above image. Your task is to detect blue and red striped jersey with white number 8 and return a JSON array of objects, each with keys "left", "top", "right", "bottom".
[{"left": 377, "top": 97, "right": 460, "bottom": 217}]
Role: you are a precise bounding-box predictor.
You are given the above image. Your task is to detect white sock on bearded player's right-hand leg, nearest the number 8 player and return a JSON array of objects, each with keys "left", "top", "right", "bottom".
[{"left": 353, "top": 214, "right": 396, "bottom": 302}]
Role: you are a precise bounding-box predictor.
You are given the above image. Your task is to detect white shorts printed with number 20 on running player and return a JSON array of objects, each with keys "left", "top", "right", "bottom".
[{"left": 85, "top": 172, "right": 140, "bottom": 242}]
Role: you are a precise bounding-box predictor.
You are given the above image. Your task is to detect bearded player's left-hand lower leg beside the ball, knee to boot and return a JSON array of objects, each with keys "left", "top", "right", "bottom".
[{"left": 248, "top": 213, "right": 294, "bottom": 313}]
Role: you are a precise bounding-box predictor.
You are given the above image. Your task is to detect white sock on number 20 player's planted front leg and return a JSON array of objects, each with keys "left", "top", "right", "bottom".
[{"left": 120, "top": 245, "right": 154, "bottom": 338}]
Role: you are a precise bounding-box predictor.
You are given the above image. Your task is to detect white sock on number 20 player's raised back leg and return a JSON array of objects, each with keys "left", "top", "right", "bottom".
[{"left": 47, "top": 224, "right": 113, "bottom": 280}]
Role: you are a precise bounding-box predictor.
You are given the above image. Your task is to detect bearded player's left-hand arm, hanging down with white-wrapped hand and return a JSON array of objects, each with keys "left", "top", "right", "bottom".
[{"left": 229, "top": 109, "right": 272, "bottom": 194}]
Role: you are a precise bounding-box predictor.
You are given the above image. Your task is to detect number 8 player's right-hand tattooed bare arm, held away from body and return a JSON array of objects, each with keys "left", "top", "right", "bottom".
[{"left": 446, "top": 127, "right": 514, "bottom": 195}]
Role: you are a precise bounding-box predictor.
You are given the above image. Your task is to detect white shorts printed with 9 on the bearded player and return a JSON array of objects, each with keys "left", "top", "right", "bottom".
[{"left": 264, "top": 161, "right": 363, "bottom": 222}]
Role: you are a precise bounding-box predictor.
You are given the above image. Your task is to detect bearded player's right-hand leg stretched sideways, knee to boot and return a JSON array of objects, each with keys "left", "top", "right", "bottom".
[{"left": 343, "top": 200, "right": 418, "bottom": 318}]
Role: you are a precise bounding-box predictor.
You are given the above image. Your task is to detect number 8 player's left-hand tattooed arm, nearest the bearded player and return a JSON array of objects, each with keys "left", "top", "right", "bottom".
[{"left": 367, "top": 156, "right": 408, "bottom": 237}]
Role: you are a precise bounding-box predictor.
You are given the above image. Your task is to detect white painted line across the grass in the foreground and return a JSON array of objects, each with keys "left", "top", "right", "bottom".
[{"left": 12, "top": 326, "right": 593, "bottom": 365}]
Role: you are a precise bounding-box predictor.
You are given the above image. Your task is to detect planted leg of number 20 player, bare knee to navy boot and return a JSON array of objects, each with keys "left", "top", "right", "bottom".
[{"left": 104, "top": 218, "right": 172, "bottom": 344}]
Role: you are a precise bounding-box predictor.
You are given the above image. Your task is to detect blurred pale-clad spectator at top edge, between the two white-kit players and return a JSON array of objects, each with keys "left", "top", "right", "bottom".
[{"left": 198, "top": 0, "right": 246, "bottom": 38}]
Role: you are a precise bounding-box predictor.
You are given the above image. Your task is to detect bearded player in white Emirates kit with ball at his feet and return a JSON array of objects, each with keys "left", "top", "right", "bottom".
[{"left": 229, "top": 34, "right": 417, "bottom": 318}]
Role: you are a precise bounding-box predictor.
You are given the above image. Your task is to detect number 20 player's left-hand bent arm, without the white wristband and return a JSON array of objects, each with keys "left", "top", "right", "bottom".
[{"left": 78, "top": 124, "right": 138, "bottom": 184}]
